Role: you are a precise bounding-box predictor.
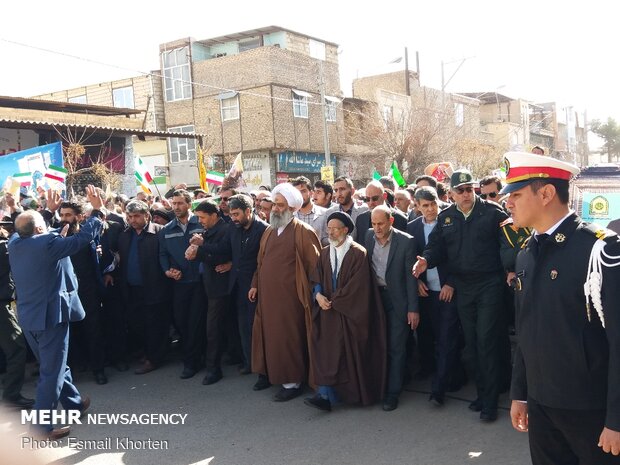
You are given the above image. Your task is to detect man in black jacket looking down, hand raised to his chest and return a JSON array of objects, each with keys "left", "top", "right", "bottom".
[{"left": 186, "top": 200, "right": 231, "bottom": 385}]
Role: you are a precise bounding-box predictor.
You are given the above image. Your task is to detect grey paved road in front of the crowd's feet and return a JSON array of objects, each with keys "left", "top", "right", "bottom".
[{"left": 0, "top": 354, "right": 530, "bottom": 465}]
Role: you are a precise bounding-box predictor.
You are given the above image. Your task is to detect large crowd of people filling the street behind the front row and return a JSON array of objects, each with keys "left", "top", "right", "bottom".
[{"left": 0, "top": 151, "right": 620, "bottom": 463}]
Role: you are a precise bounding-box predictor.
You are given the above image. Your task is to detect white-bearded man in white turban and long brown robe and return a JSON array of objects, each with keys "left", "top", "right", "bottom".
[{"left": 248, "top": 183, "right": 321, "bottom": 402}]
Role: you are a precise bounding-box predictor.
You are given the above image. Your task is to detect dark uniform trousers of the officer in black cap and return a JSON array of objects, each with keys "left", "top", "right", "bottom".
[{"left": 456, "top": 273, "right": 508, "bottom": 408}]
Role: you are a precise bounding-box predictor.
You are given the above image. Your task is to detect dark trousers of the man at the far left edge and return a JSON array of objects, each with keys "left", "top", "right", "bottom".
[{"left": 0, "top": 300, "right": 27, "bottom": 400}]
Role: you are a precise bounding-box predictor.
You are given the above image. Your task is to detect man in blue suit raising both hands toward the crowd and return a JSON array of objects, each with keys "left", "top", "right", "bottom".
[{"left": 8, "top": 186, "right": 102, "bottom": 439}]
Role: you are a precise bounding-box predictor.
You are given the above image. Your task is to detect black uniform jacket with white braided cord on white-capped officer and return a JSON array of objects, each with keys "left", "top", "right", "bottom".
[{"left": 511, "top": 214, "right": 620, "bottom": 431}]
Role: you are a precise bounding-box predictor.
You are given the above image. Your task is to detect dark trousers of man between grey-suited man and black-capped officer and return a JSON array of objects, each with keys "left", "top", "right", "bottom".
[{"left": 419, "top": 290, "right": 459, "bottom": 394}]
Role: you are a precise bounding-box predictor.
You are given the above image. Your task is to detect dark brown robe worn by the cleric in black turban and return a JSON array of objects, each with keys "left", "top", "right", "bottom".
[{"left": 311, "top": 242, "right": 387, "bottom": 405}]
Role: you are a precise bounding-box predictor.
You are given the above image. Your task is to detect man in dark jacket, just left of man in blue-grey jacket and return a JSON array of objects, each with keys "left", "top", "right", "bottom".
[{"left": 112, "top": 200, "right": 171, "bottom": 375}]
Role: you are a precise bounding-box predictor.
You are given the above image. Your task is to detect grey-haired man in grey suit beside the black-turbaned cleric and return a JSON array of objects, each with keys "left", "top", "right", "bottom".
[{"left": 365, "top": 205, "right": 420, "bottom": 411}]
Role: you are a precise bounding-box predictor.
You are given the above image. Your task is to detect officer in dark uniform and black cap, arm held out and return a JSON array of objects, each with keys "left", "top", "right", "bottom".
[{"left": 413, "top": 170, "right": 508, "bottom": 421}]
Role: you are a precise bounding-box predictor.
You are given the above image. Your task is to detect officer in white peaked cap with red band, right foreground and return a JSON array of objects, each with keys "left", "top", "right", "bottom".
[{"left": 502, "top": 152, "right": 620, "bottom": 465}]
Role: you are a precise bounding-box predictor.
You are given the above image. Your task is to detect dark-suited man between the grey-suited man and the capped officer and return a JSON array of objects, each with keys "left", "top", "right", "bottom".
[{"left": 407, "top": 186, "right": 460, "bottom": 405}]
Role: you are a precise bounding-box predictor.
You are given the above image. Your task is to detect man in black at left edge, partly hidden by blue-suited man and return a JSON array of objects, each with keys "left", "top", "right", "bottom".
[{"left": 0, "top": 221, "right": 34, "bottom": 408}]
